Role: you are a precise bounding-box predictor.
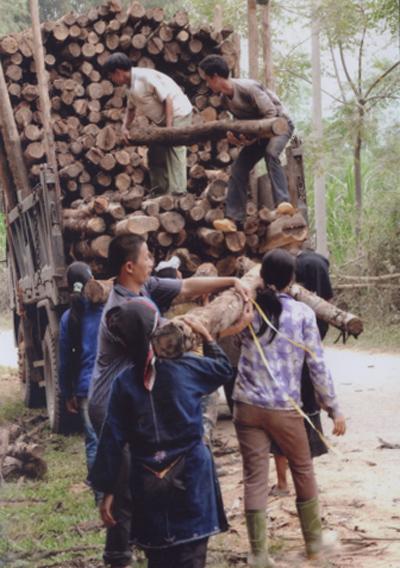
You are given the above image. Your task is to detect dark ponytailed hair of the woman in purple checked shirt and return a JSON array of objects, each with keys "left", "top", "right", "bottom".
[{"left": 257, "top": 249, "right": 295, "bottom": 343}]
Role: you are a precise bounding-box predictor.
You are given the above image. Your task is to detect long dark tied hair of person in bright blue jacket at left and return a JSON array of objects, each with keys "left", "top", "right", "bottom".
[{"left": 67, "top": 262, "right": 92, "bottom": 358}]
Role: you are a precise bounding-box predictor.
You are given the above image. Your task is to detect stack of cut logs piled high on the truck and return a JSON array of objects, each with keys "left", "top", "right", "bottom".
[{"left": 0, "top": 0, "right": 307, "bottom": 277}]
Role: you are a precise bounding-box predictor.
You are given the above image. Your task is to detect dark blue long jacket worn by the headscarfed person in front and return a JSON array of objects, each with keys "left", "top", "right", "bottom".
[{"left": 89, "top": 342, "right": 232, "bottom": 548}]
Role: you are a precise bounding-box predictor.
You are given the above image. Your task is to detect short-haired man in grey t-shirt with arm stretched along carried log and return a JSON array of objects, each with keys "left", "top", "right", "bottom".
[{"left": 88, "top": 233, "right": 250, "bottom": 568}]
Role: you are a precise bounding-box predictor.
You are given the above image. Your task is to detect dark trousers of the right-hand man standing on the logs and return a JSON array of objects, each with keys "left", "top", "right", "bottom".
[{"left": 226, "top": 121, "right": 294, "bottom": 221}]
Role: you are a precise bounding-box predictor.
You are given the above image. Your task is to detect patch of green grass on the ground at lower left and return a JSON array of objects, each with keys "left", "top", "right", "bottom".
[{"left": 0, "top": 378, "right": 105, "bottom": 568}]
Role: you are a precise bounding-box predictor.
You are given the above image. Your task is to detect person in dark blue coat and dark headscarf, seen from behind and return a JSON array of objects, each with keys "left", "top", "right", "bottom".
[{"left": 89, "top": 297, "right": 252, "bottom": 568}]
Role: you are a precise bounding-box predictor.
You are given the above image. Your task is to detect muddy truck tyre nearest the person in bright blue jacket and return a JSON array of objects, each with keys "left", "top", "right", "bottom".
[{"left": 42, "top": 326, "right": 67, "bottom": 434}]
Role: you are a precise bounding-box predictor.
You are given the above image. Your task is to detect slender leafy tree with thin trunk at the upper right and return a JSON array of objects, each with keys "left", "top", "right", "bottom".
[{"left": 319, "top": 0, "right": 400, "bottom": 235}]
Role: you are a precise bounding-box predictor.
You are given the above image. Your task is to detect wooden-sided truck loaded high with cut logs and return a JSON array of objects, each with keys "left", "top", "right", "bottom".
[{"left": 0, "top": 0, "right": 362, "bottom": 432}]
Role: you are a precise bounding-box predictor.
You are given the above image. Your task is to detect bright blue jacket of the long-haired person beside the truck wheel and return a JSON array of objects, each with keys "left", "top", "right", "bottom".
[{"left": 58, "top": 298, "right": 104, "bottom": 400}]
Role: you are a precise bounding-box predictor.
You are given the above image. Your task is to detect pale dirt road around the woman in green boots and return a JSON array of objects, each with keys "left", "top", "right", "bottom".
[{"left": 212, "top": 347, "right": 400, "bottom": 568}]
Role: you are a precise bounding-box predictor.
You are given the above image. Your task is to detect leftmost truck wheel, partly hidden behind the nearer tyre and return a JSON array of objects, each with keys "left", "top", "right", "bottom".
[{"left": 18, "top": 322, "right": 46, "bottom": 408}]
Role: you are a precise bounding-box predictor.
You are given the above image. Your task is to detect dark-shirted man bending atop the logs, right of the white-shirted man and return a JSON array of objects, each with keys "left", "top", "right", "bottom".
[{"left": 200, "top": 55, "right": 294, "bottom": 232}]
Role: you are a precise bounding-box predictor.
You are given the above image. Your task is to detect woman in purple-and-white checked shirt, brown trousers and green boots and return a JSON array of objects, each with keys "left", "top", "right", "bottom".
[{"left": 225, "top": 249, "right": 346, "bottom": 568}]
